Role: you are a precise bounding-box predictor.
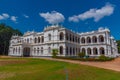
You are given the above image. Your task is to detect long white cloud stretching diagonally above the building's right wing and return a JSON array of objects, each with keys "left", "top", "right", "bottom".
[{"left": 69, "top": 3, "right": 114, "bottom": 22}]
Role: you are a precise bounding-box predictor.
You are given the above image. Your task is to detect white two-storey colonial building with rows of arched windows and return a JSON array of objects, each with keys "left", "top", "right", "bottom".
[{"left": 9, "top": 25, "right": 118, "bottom": 57}]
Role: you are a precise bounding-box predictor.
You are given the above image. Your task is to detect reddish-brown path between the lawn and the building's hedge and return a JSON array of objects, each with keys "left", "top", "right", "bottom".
[{"left": 41, "top": 58, "right": 120, "bottom": 71}]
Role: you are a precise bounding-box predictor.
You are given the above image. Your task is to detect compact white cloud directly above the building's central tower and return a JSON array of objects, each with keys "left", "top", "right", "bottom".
[{"left": 39, "top": 11, "right": 65, "bottom": 24}]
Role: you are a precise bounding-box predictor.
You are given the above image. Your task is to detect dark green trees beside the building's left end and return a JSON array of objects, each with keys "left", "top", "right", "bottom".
[{"left": 0, "top": 23, "right": 22, "bottom": 55}]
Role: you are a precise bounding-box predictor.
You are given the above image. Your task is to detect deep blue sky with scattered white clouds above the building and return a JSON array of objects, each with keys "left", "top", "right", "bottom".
[{"left": 0, "top": 0, "right": 120, "bottom": 40}]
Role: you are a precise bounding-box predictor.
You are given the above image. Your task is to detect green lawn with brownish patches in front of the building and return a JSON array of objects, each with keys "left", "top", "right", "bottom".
[{"left": 0, "top": 58, "right": 120, "bottom": 80}]
